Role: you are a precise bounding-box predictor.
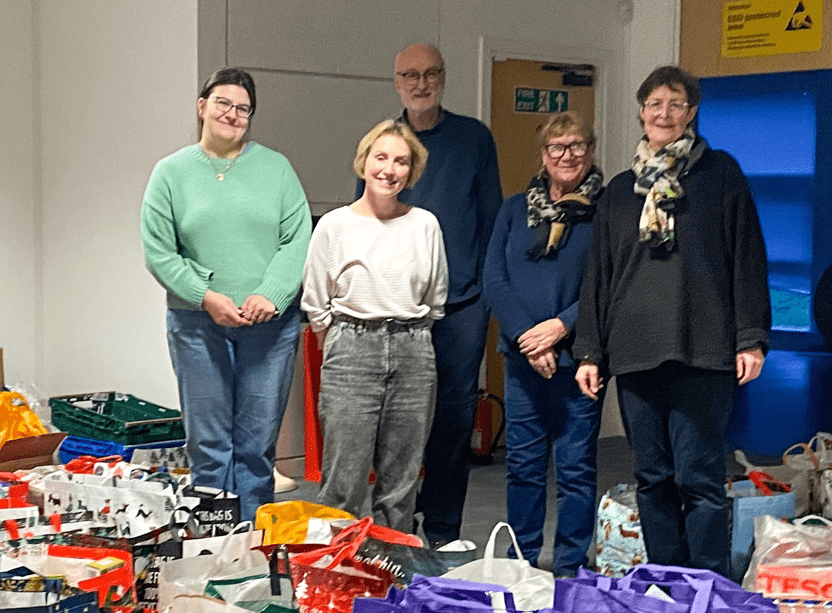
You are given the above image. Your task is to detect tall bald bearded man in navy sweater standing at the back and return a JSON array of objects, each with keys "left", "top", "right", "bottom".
[{"left": 356, "top": 44, "right": 503, "bottom": 546}]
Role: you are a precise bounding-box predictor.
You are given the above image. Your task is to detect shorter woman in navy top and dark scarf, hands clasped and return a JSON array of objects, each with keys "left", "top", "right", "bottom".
[{"left": 483, "top": 113, "right": 604, "bottom": 576}]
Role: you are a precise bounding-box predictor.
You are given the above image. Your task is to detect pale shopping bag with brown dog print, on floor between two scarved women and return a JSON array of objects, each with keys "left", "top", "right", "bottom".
[{"left": 595, "top": 483, "right": 647, "bottom": 577}]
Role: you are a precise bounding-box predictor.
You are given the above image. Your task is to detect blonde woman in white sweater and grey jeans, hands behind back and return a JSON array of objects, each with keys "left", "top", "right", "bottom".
[{"left": 301, "top": 120, "right": 448, "bottom": 532}]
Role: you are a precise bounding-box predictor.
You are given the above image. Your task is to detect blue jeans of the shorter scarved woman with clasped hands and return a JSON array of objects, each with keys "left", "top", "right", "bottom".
[{"left": 505, "top": 351, "right": 603, "bottom": 576}]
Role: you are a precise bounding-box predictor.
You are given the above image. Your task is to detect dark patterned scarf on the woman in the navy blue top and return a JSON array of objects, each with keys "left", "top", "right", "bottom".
[{"left": 526, "top": 165, "right": 604, "bottom": 260}]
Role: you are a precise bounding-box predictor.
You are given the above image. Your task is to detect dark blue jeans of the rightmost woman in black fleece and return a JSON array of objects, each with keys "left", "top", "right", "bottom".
[{"left": 617, "top": 362, "right": 736, "bottom": 577}]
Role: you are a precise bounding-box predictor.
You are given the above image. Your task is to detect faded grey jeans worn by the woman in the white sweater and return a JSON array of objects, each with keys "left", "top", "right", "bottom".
[{"left": 318, "top": 320, "right": 436, "bottom": 532}]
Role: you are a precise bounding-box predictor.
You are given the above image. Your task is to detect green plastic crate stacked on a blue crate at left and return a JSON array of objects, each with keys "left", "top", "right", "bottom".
[{"left": 49, "top": 392, "right": 185, "bottom": 445}]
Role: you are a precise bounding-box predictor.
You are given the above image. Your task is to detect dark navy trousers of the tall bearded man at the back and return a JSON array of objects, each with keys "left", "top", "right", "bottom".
[{"left": 416, "top": 296, "right": 488, "bottom": 543}]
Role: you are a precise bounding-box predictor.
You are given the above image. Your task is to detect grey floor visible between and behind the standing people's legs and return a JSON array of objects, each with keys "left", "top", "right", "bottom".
[{"left": 275, "top": 436, "right": 635, "bottom": 570}]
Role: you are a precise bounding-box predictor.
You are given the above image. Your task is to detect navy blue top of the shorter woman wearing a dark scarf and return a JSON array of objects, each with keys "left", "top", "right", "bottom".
[{"left": 483, "top": 193, "right": 592, "bottom": 368}]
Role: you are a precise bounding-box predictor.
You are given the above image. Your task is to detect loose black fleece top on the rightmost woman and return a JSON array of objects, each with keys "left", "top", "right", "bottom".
[{"left": 573, "top": 149, "right": 771, "bottom": 375}]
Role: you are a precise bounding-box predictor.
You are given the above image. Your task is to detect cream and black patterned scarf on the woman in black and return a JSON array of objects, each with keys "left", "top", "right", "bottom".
[{"left": 632, "top": 128, "right": 708, "bottom": 251}]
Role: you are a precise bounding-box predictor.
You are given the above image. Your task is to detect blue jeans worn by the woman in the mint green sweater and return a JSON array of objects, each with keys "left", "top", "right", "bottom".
[{"left": 167, "top": 307, "right": 300, "bottom": 520}]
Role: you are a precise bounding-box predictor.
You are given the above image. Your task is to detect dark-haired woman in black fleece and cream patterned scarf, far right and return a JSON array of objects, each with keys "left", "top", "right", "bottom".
[{"left": 574, "top": 66, "right": 771, "bottom": 576}]
